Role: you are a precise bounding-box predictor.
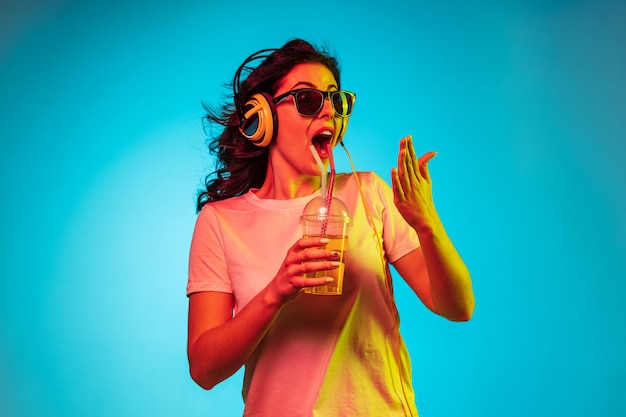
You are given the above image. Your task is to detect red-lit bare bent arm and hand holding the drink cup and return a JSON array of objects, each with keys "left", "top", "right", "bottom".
[{"left": 187, "top": 238, "right": 339, "bottom": 389}]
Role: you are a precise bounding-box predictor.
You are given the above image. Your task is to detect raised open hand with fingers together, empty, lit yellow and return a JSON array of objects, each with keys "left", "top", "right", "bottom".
[{"left": 391, "top": 136, "right": 438, "bottom": 232}]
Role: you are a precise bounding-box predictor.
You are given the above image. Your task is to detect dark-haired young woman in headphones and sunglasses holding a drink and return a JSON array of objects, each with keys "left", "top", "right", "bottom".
[{"left": 187, "top": 40, "right": 474, "bottom": 417}]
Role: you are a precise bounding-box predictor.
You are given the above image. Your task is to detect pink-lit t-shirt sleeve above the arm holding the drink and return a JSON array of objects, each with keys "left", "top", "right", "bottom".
[{"left": 187, "top": 204, "right": 232, "bottom": 296}]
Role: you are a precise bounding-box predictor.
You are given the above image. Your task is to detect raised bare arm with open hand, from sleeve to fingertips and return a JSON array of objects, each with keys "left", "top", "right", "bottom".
[{"left": 391, "top": 137, "right": 474, "bottom": 321}]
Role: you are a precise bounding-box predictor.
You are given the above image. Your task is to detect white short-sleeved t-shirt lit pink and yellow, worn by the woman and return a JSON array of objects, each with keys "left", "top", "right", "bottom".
[{"left": 187, "top": 172, "right": 419, "bottom": 417}]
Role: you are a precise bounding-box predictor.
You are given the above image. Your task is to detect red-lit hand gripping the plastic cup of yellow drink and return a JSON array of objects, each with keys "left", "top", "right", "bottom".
[{"left": 268, "top": 237, "right": 341, "bottom": 304}]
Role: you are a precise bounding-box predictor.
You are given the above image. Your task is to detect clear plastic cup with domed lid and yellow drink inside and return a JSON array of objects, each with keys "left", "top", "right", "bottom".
[{"left": 300, "top": 197, "right": 352, "bottom": 295}]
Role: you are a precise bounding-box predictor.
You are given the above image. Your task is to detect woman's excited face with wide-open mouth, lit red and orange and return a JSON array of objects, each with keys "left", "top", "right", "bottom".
[{"left": 270, "top": 62, "right": 348, "bottom": 176}]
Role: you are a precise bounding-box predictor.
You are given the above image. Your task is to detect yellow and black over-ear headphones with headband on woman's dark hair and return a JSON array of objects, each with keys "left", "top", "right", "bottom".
[{"left": 233, "top": 48, "right": 278, "bottom": 147}]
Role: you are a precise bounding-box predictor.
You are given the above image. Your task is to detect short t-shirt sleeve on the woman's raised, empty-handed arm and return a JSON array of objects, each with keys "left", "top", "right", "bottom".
[{"left": 371, "top": 172, "right": 420, "bottom": 263}]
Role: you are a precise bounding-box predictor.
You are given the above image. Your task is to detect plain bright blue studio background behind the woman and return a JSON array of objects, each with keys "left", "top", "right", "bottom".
[{"left": 0, "top": 0, "right": 626, "bottom": 417}]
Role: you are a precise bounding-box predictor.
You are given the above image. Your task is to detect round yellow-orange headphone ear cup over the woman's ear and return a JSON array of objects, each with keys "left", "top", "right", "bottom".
[{"left": 239, "top": 93, "right": 278, "bottom": 147}]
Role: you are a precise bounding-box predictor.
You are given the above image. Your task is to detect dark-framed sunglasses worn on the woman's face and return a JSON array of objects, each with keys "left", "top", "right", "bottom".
[{"left": 273, "top": 88, "right": 356, "bottom": 117}]
